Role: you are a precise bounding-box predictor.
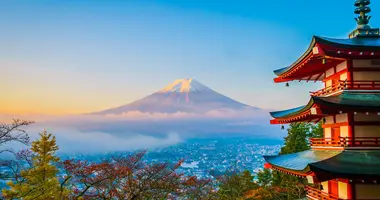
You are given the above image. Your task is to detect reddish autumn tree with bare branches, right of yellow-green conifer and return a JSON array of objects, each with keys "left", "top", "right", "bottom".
[{"left": 64, "top": 151, "right": 212, "bottom": 200}]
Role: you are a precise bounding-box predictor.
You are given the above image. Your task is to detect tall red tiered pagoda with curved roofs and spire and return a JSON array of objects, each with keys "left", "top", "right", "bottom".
[{"left": 264, "top": 0, "right": 380, "bottom": 200}]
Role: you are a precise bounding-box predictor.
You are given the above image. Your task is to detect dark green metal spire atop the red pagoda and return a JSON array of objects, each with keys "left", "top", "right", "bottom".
[{"left": 348, "top": 0, "right": 380, "bottom": 38}]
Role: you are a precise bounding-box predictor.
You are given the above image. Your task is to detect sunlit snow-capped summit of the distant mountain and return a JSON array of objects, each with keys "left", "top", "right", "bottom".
[{"left": 159, "top": 78, "right": 211, "bottom": 93}]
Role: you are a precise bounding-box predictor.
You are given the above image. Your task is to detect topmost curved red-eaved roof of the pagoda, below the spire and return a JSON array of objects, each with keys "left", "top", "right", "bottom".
[{"left": 273, "top": 36, "right": 380, "bottom": 82}]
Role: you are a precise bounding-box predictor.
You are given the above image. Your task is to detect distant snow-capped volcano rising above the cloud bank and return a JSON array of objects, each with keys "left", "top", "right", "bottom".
[{"left": 91, "top": 78, "right": 261, "bottom": 115}]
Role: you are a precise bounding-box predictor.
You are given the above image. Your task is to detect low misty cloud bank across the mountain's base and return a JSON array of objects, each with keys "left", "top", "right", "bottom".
[{"left": 0, "top": 109, "right": 282, "bottom": 153}]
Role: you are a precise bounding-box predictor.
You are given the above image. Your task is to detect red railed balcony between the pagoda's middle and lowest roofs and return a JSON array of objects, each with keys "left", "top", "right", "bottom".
[{"left": 310, "top": 137, "right": 380, "bottom": 148}]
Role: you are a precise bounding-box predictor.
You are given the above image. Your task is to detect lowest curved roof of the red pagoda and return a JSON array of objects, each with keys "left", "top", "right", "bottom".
[{"left": 264, "top": 150, "right": 380, "bottom": 181}]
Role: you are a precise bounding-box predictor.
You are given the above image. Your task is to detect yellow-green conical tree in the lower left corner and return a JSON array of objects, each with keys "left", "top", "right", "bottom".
[{"left": 3, "top": 131, "right": 67, "bottom": 200}]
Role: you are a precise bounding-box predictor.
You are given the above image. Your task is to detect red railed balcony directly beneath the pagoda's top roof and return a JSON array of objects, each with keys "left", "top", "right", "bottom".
[{"left": 310, "top": 81, "right": 380, "bottom": 96}]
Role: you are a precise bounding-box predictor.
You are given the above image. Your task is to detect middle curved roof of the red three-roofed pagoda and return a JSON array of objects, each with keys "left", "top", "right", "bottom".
[{"left": 270, "top": 91, "right": 380, "bottom": 124}]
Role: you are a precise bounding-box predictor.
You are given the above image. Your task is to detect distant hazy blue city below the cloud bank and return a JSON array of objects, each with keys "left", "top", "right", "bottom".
[{"left": 63, "top": 138, "right": 282, "bottom": 178}]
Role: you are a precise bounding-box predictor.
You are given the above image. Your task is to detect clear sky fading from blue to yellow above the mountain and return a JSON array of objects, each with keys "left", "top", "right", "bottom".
[{"left": 0, "top": 0, "right": 380, "bottom": 114}]
